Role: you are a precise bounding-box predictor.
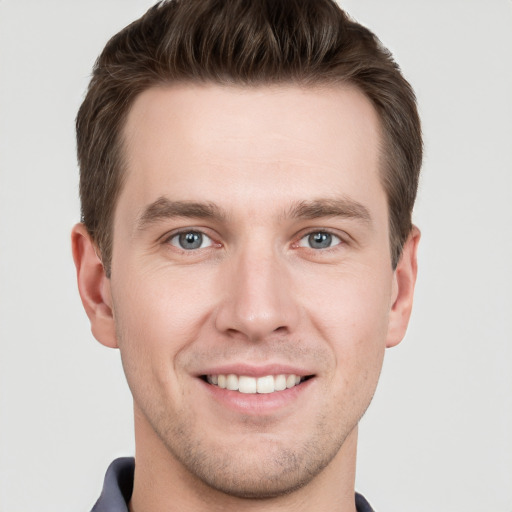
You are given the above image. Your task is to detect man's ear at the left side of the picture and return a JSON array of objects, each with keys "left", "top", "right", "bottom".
[{"left": 71, "top": 224, "right": 118, "bottom": 348}]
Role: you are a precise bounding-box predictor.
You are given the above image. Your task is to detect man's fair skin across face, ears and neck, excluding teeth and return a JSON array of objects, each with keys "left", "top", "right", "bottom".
[{"left": 73, "top": 84, "right": 419, "bottom": 512}]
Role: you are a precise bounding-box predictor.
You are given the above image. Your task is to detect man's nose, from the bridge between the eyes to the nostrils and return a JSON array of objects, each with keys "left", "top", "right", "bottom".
[{"left": 216, "top": 243, "right": 300, "bottom": 341}]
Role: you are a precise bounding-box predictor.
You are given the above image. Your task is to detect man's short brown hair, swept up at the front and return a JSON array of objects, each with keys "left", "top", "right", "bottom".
[{"left": 76, "top": 0, "right": 422, "bottom": 276}]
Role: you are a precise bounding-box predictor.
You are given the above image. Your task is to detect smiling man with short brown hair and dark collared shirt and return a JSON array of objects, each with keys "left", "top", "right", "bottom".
[{"left": 72, "top": 0, "right": 422, "bottom": 512}]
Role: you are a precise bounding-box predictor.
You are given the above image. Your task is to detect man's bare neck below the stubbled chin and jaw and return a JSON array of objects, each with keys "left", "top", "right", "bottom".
[{"left": 129, "top": 409, "right": 357, "bottom": 512}]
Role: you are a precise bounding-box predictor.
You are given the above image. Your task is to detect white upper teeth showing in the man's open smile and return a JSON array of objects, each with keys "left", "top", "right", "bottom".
[{"left": 202, "top": 373, "right": 313, "bottom": 394}]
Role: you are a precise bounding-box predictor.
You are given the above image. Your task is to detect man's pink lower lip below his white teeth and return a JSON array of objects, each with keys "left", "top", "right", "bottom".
[{"left": 199, "top": 378, "right": 315, "bottom": 416}]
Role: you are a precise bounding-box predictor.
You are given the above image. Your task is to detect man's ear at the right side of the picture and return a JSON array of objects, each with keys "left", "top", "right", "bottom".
[{"left": 386, "top": 226, "right": 421, "bottom": 348}]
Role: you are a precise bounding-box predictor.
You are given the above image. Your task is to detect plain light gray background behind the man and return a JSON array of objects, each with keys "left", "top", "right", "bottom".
[{"left": 0, "top": 0, "right": 512, "bottom": 512}]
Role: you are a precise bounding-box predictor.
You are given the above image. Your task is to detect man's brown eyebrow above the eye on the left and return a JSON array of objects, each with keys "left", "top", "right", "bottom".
[{"left": 136, "top": 196, "right": 226, "bottom": 231}]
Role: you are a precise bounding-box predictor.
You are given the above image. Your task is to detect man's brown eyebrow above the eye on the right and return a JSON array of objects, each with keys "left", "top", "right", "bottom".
[{"left": 285, "top": 197, "right": 372, "bottom": 224}]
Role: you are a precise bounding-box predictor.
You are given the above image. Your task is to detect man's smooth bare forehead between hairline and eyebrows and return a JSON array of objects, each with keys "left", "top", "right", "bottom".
[{"left": 121, "top": 84, "right": 383, "bottom": 220}]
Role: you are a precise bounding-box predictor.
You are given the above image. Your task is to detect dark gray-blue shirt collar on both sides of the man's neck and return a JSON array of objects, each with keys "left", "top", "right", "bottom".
[{"left": 91, "top": 457, "right": 373, "bottom": 512}]
